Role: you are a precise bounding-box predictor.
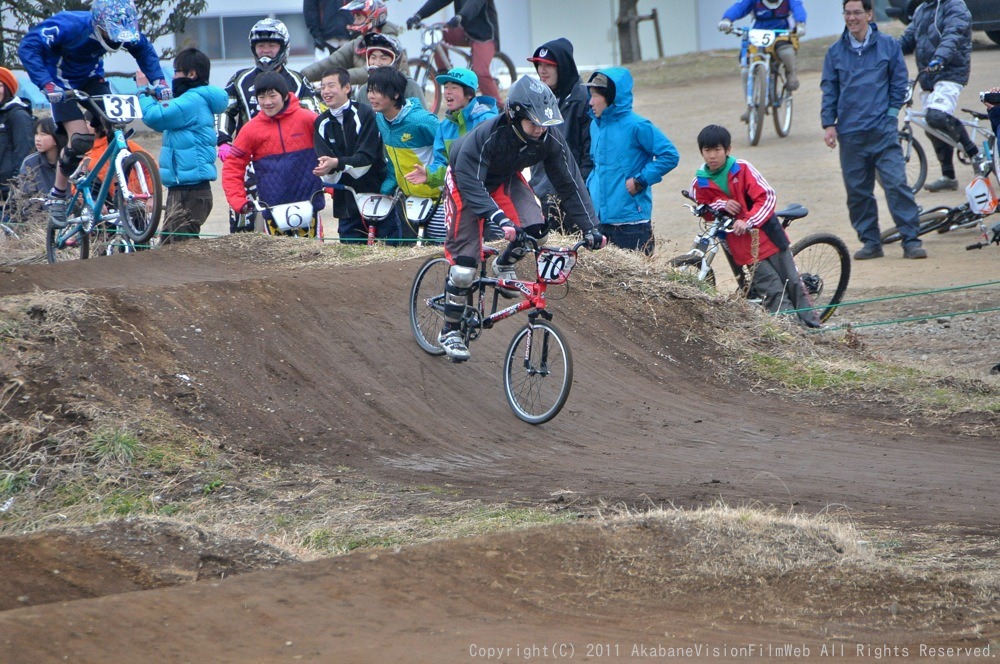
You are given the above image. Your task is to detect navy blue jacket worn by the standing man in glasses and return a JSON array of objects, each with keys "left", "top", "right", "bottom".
[{"left": 820, "top": 23, "right": 909, "bottom": 134}]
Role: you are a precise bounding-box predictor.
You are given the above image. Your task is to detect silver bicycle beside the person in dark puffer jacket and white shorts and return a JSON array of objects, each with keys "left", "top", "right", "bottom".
[{"left": 899, "top": 72, "right": 996, "bottom": 193}]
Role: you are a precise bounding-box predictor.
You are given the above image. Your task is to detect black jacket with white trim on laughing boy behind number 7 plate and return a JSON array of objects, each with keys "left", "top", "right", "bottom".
[{"left": 313, "top": 102, "right": 386, "bottom": 218}]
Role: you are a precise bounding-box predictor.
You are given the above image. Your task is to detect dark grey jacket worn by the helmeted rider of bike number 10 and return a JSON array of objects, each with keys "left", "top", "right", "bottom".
[{"left": 448, "top": 115, "right": 597, "bottom": 232}]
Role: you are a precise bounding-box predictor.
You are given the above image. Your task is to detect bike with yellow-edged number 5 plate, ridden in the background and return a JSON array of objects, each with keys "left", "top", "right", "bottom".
[{"left": 730, "top": 27, "right": 799, "bottom": 145}]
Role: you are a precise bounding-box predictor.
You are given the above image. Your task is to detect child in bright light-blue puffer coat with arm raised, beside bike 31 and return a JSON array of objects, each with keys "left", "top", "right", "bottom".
[{"left": 136, "top": 48, "right": 229, "bottom": 244}]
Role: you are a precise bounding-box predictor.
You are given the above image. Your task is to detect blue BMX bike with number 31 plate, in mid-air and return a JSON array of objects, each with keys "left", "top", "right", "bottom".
[{"left": 45, "top": 90, "right": 163, "bottom": 263}]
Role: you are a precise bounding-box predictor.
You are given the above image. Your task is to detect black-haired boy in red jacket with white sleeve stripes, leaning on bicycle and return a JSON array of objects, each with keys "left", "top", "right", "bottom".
[{"left": 691, "top": 125, "right": 822, "bottom": 327}]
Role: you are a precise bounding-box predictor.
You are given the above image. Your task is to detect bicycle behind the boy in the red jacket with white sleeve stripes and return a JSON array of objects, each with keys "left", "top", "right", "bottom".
[{"left": 670, "top": 191, "right": 851, "bottom": 323}]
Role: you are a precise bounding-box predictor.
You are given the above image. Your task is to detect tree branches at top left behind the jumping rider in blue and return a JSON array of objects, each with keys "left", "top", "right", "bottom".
[{"left": 0, "top": 0, "right": 208, "bottom": 69}]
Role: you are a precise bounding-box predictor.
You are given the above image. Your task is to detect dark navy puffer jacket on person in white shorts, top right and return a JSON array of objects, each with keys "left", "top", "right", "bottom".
[{"left": 899, "top": 0, "right": 972, "bottom": 90}]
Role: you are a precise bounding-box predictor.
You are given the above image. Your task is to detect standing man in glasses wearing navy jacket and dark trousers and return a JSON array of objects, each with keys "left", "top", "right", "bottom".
[{"left": 820, "top": 0, "right": 927, "bottom": 260}]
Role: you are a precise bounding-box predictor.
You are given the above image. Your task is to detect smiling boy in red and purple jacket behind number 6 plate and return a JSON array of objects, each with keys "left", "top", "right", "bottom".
[{"left": 222, "top": 72, "right": 325, "bottom": 237}]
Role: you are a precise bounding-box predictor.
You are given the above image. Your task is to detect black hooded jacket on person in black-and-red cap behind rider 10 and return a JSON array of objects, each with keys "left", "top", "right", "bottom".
[{"left": 531, "top": 37, "right": 594, "bottom": 198}]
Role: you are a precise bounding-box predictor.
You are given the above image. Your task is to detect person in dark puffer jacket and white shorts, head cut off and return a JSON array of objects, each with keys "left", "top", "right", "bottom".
[{"left": 899, "top": 0, "right": 981, "bottom": 191}]
